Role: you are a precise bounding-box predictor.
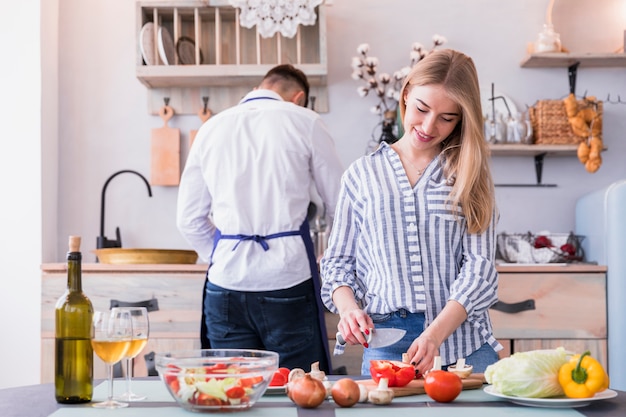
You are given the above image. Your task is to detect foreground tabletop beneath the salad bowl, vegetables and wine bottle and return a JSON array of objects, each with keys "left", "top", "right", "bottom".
[{"left": 0, "top": 376, "right": 626, "bottom": 417}]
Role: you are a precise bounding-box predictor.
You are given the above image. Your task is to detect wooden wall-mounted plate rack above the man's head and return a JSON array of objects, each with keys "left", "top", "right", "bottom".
[{"left": 136, "top": 0, "right": 328, "bottom": 114}]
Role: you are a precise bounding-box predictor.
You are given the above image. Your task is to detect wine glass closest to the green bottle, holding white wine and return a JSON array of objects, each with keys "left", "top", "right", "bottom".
[{"left": 91, "top": 308, "right": 133, "bottom": 408}]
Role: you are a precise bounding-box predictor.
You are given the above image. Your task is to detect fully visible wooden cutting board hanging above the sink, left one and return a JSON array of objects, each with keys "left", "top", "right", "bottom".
[{"left": 150, "top": 102, "right": 180, "bottom": 185}]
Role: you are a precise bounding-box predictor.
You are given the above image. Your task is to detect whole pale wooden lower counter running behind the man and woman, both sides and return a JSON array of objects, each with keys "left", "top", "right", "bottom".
[{"left": 41, "top": 263, "right": 607, "bottom": 376}]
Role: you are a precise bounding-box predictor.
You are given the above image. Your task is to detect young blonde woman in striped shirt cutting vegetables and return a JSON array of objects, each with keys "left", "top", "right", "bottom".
[{"left": 321, "top": 49, "right": 502, "bottom": 375}]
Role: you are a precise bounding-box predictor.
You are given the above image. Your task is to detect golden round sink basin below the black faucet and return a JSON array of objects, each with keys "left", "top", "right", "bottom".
[{"left": 92, "top": 248, "right": 198, "bottom": 265}]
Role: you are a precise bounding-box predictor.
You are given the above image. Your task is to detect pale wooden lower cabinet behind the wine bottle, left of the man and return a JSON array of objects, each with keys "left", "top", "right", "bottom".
[{"left": 41, "top": 264, "right": 206, "bottom": 383}]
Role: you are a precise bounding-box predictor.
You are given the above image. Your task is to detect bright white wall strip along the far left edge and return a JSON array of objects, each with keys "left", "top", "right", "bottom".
[{"left": 0, "top": 0, "right": 42, "bottom": 388}]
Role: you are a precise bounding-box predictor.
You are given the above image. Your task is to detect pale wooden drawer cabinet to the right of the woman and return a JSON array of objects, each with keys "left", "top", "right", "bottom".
[{"left": 490, "top": 264, "right": 607, "bottom": 367}]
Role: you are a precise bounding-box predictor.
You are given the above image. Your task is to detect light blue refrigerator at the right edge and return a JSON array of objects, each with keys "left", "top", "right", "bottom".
[{"left": 576, "top": 179, "right": 626, "bottom": 391}]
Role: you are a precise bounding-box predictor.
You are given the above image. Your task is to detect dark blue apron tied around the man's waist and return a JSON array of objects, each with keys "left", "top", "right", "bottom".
[{"left": 200, "top": 218, "right": 332, "bottom": 370}]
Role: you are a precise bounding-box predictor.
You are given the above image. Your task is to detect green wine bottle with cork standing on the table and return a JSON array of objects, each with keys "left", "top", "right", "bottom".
[{"left": 54, "top": 236, "right": 93, "bottom": 404}]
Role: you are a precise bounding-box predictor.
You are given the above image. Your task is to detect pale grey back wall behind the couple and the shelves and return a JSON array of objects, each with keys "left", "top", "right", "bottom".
[{"left": 51, "top": 0, "right": 626, "bottom": 262}]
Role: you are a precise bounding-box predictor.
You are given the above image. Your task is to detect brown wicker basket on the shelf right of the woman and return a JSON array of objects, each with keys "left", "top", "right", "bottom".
[{"left": 529, "top": 100, "right": 602, "bottom": 145}]
